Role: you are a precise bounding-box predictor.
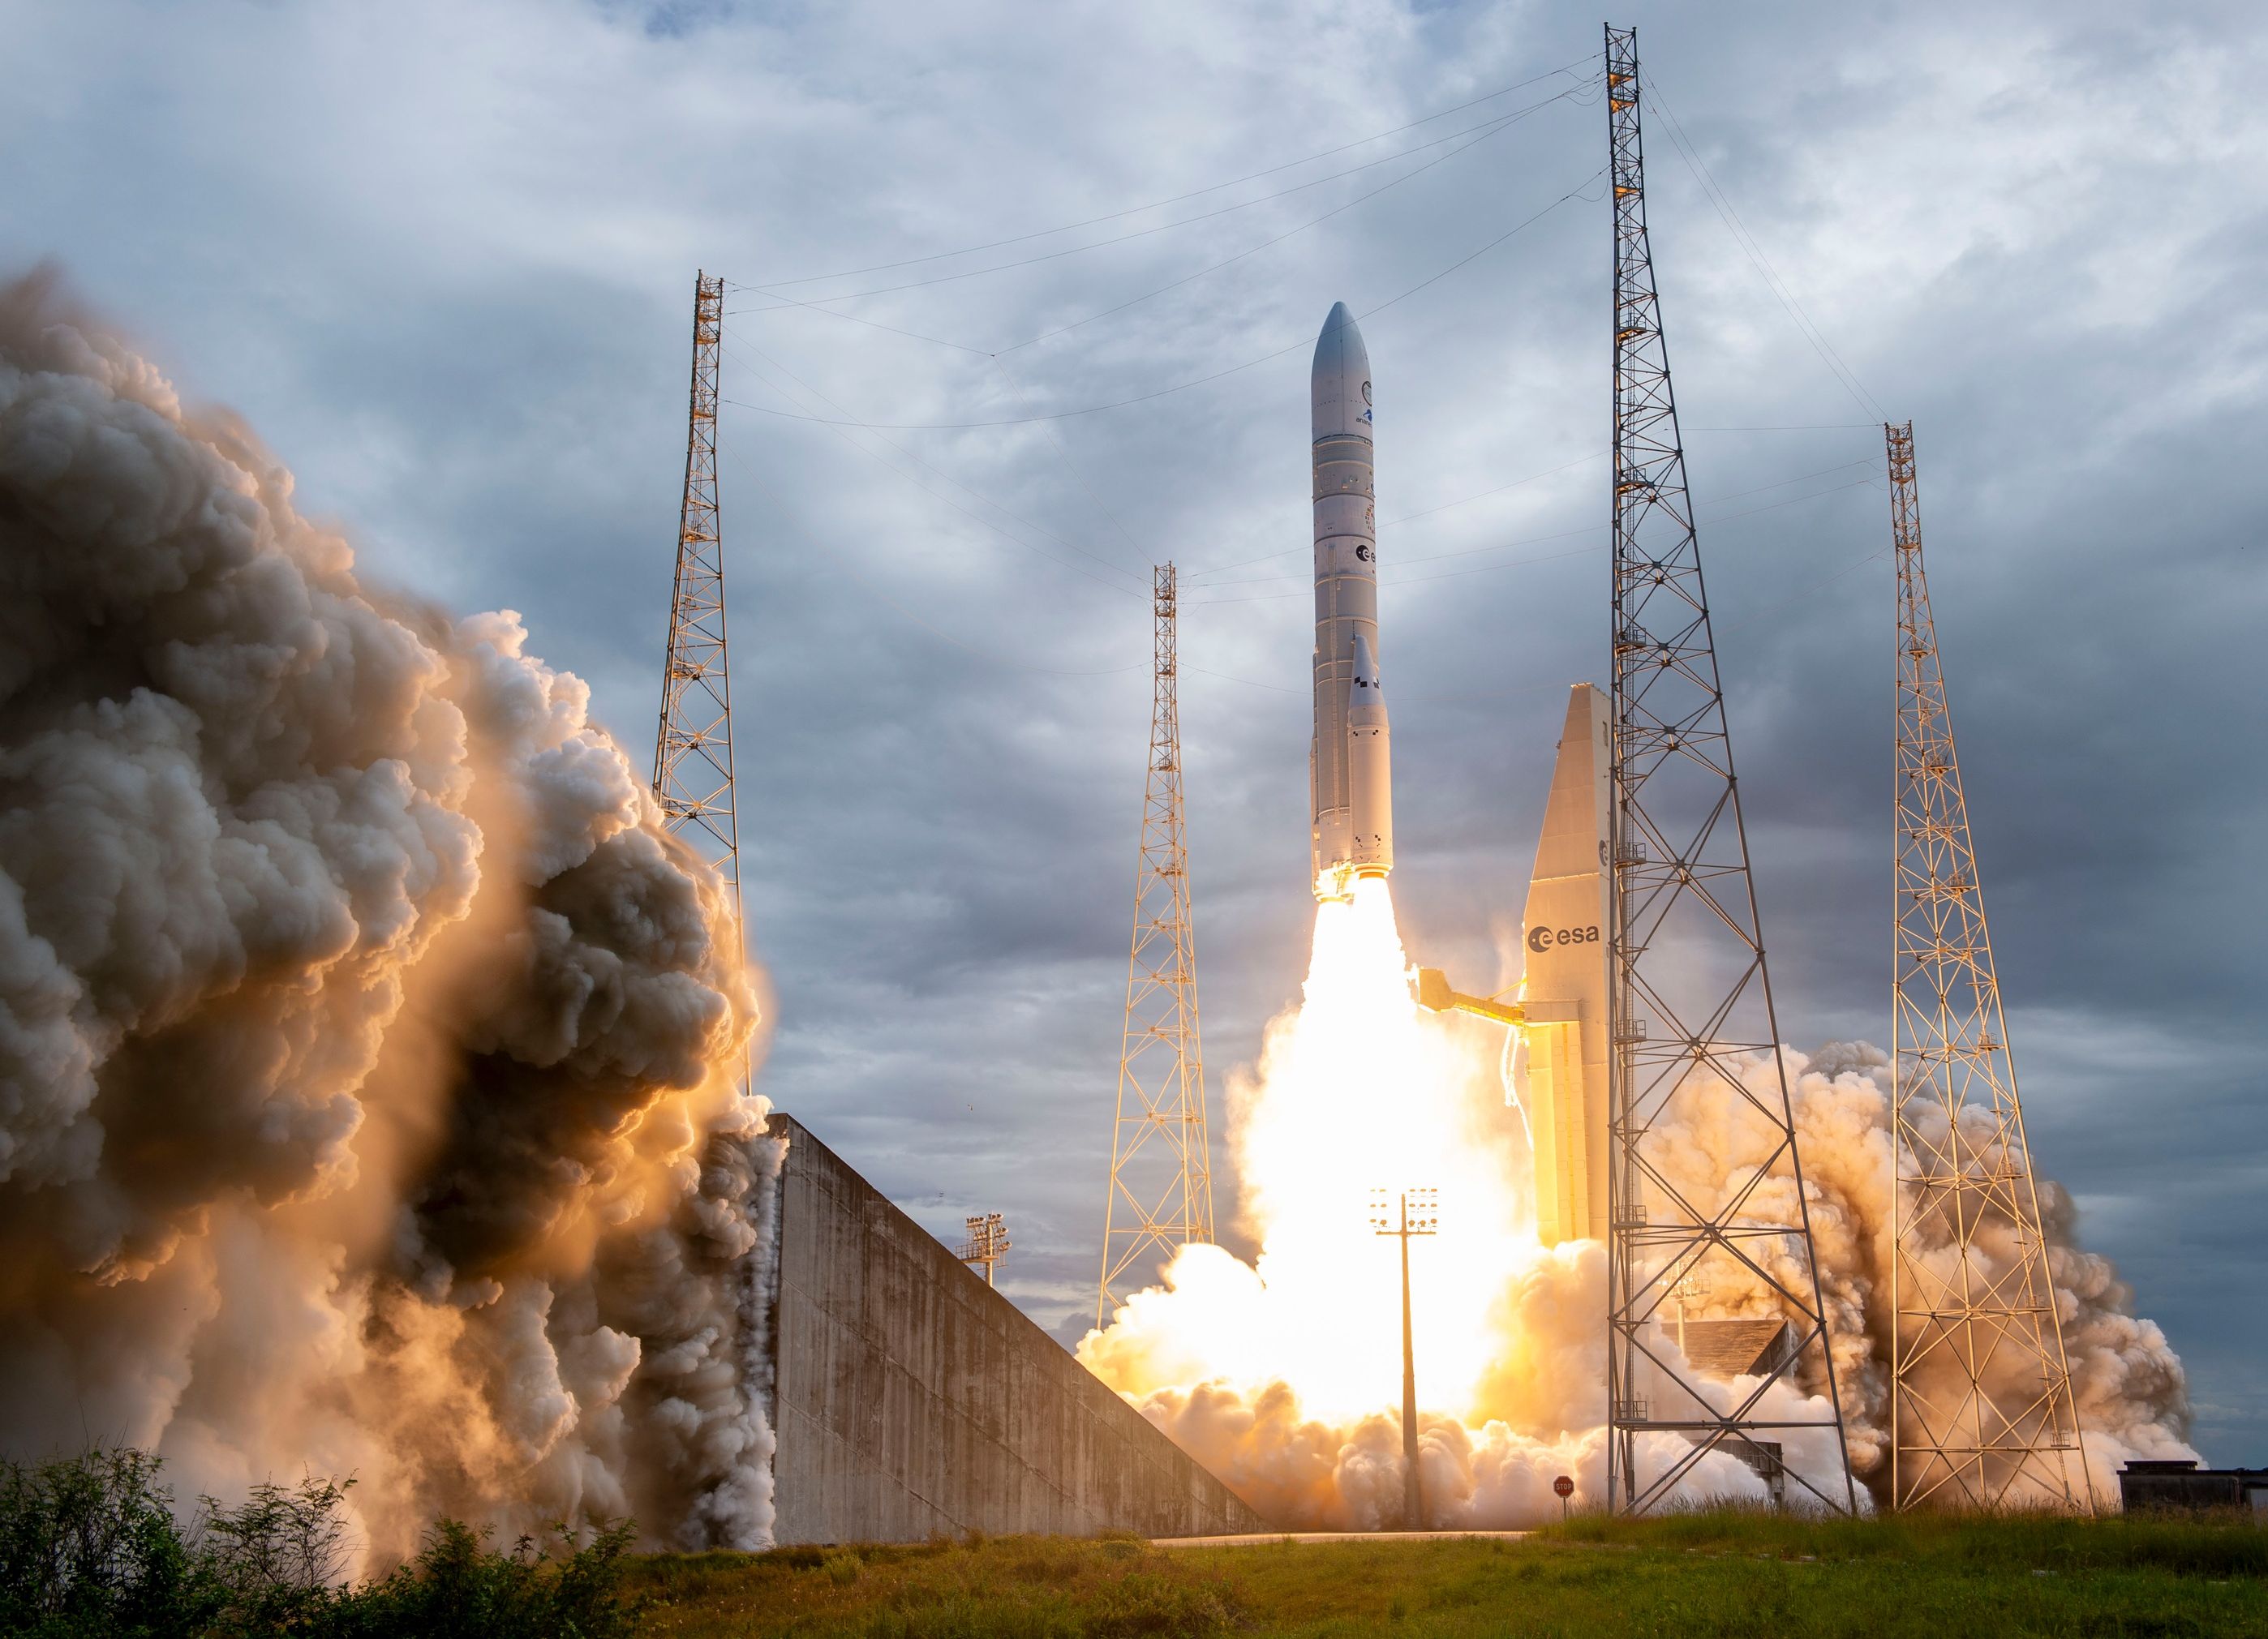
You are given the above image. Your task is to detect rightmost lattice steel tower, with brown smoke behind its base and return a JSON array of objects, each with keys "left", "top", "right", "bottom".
[{"left": 1883, "top": 422, "right": 2096, "bottom": 1510}]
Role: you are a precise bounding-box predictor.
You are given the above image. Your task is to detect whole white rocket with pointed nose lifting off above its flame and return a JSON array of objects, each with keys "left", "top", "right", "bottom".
[{"left": 1306, "top": 302, "right": 1395, "bottom": 900}]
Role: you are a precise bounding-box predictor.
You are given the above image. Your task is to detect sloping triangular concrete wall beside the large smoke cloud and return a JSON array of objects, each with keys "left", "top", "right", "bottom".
[{"left": 771, "top": 1115, "right": 1265, "bottom": 1544}]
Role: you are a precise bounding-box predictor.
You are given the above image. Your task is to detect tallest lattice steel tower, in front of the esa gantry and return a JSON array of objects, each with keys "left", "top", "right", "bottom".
[{"left": 1606, "top": 28, "right": 1858, "bottom": 1512}]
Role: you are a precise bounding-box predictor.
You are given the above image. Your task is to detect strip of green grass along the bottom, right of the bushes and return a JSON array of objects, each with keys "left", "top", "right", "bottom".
[{"left": 633, "top": 1512, "right": 2268, "bottom": 1639}]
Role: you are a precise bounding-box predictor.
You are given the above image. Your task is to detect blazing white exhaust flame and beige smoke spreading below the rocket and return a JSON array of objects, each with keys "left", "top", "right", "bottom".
[{"left": 1080, "top": 886, "right": 2196, "bottom": 1530}]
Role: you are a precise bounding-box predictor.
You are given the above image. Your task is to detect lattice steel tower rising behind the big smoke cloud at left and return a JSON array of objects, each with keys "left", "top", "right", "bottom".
[{"left": 653, "top": 274, "right": 739, "bottom": 920}]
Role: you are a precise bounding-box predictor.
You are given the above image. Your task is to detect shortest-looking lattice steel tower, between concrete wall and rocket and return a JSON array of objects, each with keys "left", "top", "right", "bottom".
[{"left": 1095, "top": 564, "right": 1213, "bottom": 1326}]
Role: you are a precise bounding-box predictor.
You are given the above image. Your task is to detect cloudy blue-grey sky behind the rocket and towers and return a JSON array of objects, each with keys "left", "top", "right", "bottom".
[{"left": 0, "top": 0, "right": 2268, "bottom": 1462}]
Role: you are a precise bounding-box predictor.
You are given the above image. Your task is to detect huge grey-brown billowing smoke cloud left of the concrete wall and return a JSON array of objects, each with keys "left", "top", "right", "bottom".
[{"left": 0, "top": 277, "right": 780, "bottom": 1560}]
